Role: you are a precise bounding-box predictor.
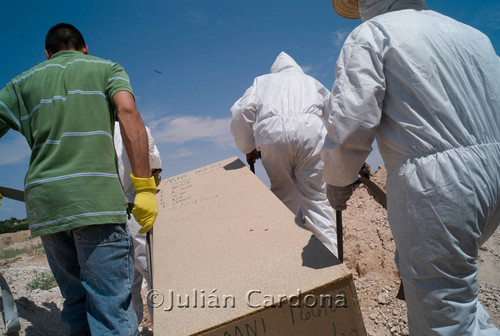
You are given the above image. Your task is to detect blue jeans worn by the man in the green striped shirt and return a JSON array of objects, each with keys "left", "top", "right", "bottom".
[{"left": 41, "top": 224, "right": 138, "bottom": 336}]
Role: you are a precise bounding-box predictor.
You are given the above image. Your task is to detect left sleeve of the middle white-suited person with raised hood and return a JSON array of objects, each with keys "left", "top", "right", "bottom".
[{"left": 231, "top": 81, "right": 257, "bottom": 154}]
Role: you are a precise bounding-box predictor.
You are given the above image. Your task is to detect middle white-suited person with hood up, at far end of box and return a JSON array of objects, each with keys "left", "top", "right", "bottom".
[{"left": 231, "top": 52, "right": 338, "bottom": 256}]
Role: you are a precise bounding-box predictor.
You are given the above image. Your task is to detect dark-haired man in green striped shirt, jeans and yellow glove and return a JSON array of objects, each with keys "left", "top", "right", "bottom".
[{"left": 0, "top": 24, "right": 157, "bottom": 335}]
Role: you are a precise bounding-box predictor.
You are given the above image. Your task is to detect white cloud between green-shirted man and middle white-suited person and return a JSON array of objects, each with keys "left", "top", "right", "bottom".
[{"left": 149, "top": 116, "right": 233, "bottom": 147}]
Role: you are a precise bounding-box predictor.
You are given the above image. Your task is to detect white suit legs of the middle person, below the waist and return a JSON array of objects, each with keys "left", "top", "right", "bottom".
[{"left": 259, "top": 115, "right": 338, "bottom": 256}]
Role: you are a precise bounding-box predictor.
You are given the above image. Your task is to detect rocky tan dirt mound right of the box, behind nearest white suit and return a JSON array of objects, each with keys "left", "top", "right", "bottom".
[{"left": 342, "top": 167, "right": 500, "bottom": 336}]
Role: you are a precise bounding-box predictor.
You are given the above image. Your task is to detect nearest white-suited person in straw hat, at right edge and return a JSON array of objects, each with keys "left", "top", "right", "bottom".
[{"left": 322, "top": 0, "right": 500, "bottom": 336}]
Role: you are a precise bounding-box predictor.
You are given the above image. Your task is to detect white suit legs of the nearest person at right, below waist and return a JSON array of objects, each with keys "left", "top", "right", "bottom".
[{"left": 387, "top": 146, "right": 500, "bottom": 336}]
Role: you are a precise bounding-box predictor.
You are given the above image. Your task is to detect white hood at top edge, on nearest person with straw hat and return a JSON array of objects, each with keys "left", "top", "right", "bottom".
[{"left": 358, "top": 0, "right": 427, "bottom": 22}]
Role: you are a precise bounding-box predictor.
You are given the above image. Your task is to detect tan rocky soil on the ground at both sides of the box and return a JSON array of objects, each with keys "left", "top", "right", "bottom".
[{"left": 0, "top": 168, "right": 500, "bottom": 336}]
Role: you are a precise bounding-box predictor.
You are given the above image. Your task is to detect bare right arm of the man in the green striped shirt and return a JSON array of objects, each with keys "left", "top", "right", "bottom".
[{"left": 113, "top": 91, "right": 151, "bottom": 178}]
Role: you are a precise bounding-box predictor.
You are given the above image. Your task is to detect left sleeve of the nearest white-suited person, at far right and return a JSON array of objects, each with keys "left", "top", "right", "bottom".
[{"left": 322, "top": 30, "right": 385, "bottom": 187}]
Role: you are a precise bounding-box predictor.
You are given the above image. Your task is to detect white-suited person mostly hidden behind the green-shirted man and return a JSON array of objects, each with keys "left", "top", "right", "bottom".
[{"left": 114, "top": 122, "right": 161, "bottom": 323}]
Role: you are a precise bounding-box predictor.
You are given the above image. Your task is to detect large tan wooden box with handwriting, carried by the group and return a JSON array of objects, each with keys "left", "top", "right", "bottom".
[{"left": 148, "top": 158, "right": 366, "bottom": 336}]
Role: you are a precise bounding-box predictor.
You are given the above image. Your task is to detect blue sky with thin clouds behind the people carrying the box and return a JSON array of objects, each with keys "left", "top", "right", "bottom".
[{"left": 0, "top": 0, "right": 500, "bottom": 220}]
